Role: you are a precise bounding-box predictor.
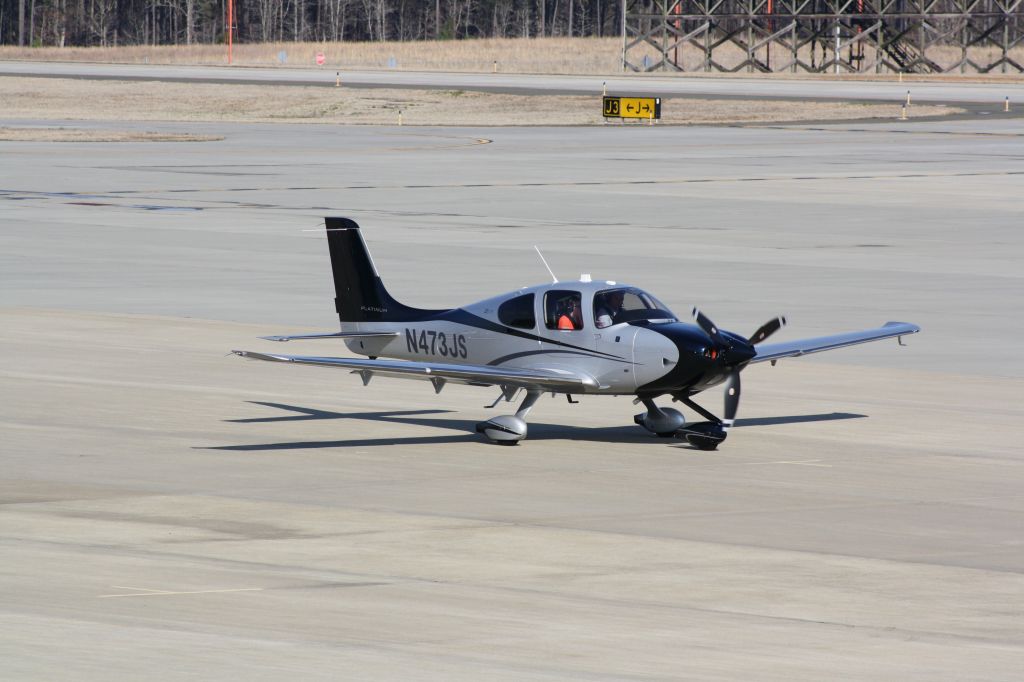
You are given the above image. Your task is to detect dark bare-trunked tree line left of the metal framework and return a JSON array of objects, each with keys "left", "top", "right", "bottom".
[{"left": 0, "top": 0, "right": 623, "bottom": 47}]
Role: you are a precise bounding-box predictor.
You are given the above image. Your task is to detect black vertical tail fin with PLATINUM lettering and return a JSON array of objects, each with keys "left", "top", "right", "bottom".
[{"left": 326, "top": 218, "right": 444, "bottom": 323}]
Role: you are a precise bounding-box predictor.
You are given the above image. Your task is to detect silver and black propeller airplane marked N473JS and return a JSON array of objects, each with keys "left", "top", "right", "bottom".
[{"left": 232, "top": 218, "right": 920, "bottom": 450}]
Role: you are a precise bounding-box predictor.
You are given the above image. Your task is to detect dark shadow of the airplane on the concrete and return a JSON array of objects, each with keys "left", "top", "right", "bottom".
[{"left": 203, "top": 400, "right": 866, "bottom": 452}]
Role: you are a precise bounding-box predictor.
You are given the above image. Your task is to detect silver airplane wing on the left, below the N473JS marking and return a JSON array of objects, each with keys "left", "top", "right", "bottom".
[{"left": 231, "top": 350, "right": 598, "bottom": 393}]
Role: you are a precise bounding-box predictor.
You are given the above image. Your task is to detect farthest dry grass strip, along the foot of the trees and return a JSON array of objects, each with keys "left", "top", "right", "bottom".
[{"left": 0, "top": 38, "right": 1024, "bottom": 79}]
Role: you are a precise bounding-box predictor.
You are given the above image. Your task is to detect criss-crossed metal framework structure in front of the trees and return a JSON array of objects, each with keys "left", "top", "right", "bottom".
[{"left": 623, "top": 0, "right": 1024, "bottom": 74}]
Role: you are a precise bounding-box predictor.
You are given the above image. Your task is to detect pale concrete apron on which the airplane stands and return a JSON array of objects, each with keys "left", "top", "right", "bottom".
[{"left": 6, "top": 99, "right": 1024, "bottom": 680}]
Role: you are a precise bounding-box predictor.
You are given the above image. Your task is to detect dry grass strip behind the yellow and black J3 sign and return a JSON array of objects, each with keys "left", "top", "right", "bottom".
[{"left": 0, "top": 78, "right": 962, "bottom": 126}]
